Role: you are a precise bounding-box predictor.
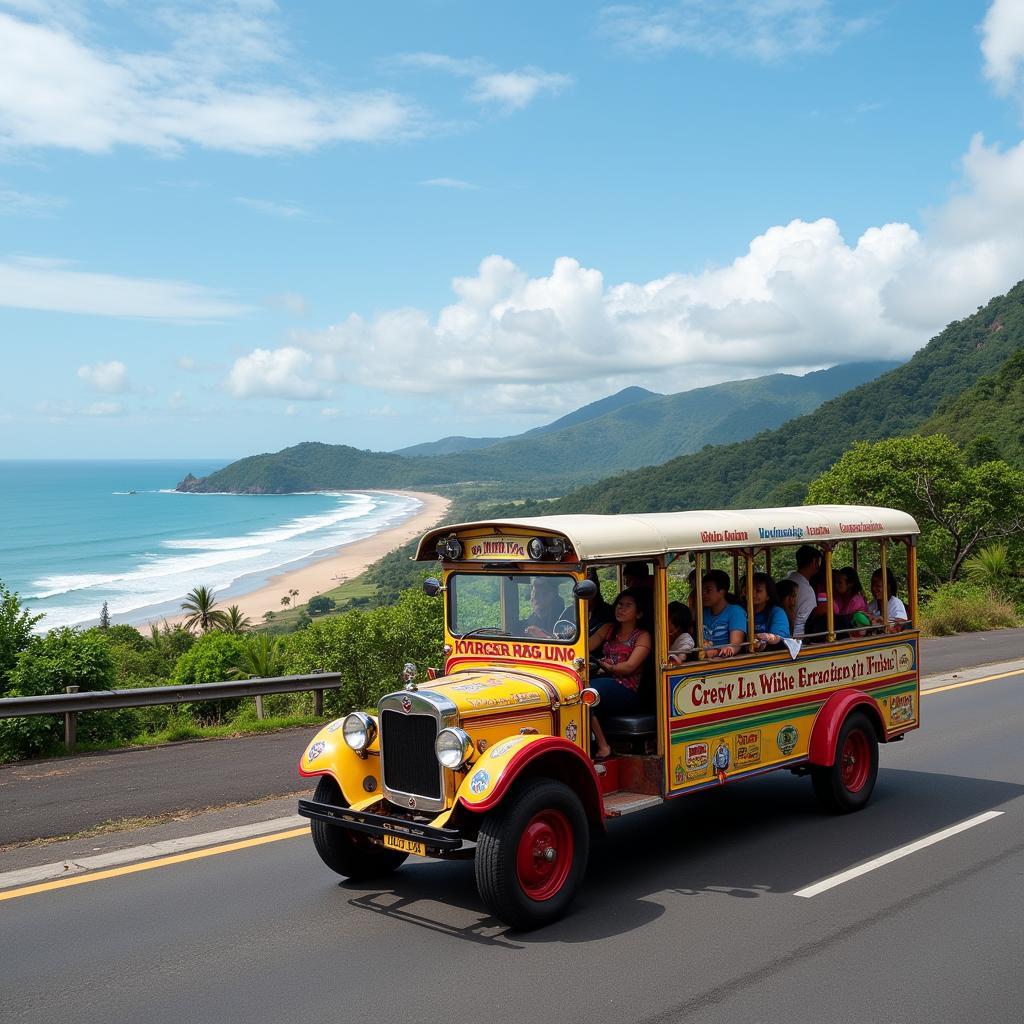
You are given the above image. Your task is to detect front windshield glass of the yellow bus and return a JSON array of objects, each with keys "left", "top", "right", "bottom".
[{"left": 449, "top": 572, "right": 580, "bottom": 643}]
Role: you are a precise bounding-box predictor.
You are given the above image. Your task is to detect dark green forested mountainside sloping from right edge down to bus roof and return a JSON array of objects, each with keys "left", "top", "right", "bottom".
[{"left": 524, "top": 282, "right": 1024, "bottom": 513}]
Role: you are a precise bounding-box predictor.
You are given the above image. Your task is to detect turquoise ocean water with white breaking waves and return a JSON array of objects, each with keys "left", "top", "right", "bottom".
[{"left": 0, "top": 460, "right": 422, "bottom": 629}]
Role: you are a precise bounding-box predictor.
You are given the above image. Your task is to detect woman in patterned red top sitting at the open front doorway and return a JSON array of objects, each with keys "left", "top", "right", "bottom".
[{"left": 590, "top": 587, "right": 651, "bottom": 761}]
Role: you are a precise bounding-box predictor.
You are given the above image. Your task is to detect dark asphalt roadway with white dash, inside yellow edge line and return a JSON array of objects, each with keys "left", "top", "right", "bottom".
[{"left": 0, "top": 659, "right": 1024, "bottom": 1024}]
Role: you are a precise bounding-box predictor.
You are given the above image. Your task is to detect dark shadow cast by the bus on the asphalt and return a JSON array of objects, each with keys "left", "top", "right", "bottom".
[{"left": 331, "top": 768, "right": 1024, "bottom": 949}]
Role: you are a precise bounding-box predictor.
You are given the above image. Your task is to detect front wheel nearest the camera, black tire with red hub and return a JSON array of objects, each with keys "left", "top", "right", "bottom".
[{"left": 476, "top": 779, "right": 590, "bottom": 931}]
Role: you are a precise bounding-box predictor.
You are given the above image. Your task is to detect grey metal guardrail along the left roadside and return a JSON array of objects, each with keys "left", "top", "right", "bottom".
[{"left": 0, "top": 672, "right": 341, "bottom": 750}]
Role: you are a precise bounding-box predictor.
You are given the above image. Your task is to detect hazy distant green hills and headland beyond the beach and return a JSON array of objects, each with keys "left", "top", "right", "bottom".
[{"left": 178, "top": 362, "right": 892, "bottom": 497}]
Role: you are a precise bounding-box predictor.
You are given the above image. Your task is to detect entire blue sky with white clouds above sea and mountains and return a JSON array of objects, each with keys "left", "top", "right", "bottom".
[{"left": 0, "top": 0, "right": 1024, "bottom": 458}]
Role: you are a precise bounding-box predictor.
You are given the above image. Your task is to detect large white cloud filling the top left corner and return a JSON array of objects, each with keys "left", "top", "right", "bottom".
[{"left": 0, "top": 2, "right": 419, "bottom": 154}]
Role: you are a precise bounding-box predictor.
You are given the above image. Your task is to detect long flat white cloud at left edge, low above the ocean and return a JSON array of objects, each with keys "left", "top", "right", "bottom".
[{"left": 0, "top": 256, "right": 247, "bottom": 321}]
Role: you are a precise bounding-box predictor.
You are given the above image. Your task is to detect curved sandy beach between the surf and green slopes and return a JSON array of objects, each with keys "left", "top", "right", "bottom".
[{"left": 147, "top": 490, "right": 452, "bottom": 630}]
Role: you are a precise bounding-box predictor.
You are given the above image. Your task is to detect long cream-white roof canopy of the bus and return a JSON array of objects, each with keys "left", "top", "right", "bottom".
[{"left": 416, "top": 505, "right": 921, "bottom": 561}]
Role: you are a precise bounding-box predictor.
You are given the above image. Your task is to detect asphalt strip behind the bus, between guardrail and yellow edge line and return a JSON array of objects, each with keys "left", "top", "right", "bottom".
[{"left": 0, "top": 629, "right": 1024, "bottom": 847}]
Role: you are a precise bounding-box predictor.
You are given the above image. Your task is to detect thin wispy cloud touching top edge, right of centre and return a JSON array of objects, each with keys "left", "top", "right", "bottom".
[{"left": 600, "top": 0, "right": 870, "bottom": 63}]
